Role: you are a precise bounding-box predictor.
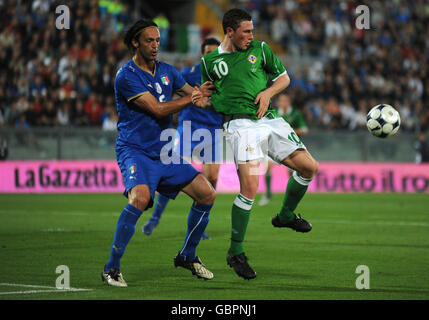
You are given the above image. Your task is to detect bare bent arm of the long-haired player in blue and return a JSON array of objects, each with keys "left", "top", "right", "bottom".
[{"left": 132, "top": 92, "right": 192, "bottom": 118}]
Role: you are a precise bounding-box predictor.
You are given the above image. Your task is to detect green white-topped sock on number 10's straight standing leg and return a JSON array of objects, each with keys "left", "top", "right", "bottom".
[{"left": 229, "top": 194, "right": 254, "bottom": 256}]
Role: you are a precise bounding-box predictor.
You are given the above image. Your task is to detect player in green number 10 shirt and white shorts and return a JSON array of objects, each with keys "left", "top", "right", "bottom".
[{"left": 192, "top": 9, "right": 318, "bottom": 279}]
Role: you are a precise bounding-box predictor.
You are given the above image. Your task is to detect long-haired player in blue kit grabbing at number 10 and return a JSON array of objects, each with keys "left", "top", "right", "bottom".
[{"left": 101, "top": 19, "right": 216, "bottom": 287}]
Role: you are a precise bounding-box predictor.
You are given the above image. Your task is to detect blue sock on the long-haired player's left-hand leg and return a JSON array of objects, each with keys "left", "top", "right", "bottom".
[{"left": 104, "top": 204, "right": 142, "bottom": 272}]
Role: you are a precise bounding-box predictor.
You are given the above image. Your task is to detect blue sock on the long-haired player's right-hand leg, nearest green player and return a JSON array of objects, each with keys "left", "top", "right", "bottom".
[{"left": 180, "top": 202, "right": 213, "bottom": 261}]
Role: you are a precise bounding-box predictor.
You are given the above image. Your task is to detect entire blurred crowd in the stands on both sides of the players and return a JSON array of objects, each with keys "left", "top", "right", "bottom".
[{"left": 0, "top": 0, "right": 429, "bottom": 141}]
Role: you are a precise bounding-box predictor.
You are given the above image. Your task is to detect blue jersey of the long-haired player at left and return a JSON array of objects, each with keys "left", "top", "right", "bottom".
[{"left": 115, "top": 59, "right": 186, "bottom": 159}]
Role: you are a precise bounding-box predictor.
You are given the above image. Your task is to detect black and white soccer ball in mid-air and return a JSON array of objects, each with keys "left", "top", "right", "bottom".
[{"left": 366, "top": 104, "right": 401, "bottom": 138}]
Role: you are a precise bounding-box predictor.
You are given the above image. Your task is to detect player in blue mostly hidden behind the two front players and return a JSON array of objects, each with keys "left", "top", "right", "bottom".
[{"left": 142, "top": 38, "right": 222, "bottom": 239}]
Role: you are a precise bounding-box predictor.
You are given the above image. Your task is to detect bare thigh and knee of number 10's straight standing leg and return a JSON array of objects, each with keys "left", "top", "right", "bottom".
[{"left": 237, "top": 160, "right": 260, "bottom": 199}]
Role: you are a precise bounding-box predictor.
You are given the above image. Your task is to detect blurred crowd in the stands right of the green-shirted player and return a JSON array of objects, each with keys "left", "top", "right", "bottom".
[{"left": 236, "top": 0, "right": 429, "bottom": 131}]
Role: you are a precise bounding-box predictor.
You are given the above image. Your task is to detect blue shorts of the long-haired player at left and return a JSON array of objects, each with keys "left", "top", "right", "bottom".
[{"left": 116, "top": 147, "right": 199, "bottom": 209}]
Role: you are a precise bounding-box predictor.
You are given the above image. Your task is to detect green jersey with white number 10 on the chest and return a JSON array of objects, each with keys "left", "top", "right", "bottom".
[{"left": 200, "top": 41, "right": 286, "bottom": 119}]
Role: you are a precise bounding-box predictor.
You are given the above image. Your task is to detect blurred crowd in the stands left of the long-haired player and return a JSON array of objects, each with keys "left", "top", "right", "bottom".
[{"left": 0, "top": 0, "right": 137, "bottom": 130}]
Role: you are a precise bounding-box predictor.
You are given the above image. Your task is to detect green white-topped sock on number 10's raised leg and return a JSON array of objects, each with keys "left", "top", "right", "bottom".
[{"left": 279, "top": 171, "right": 312, "bottom": 222}]
